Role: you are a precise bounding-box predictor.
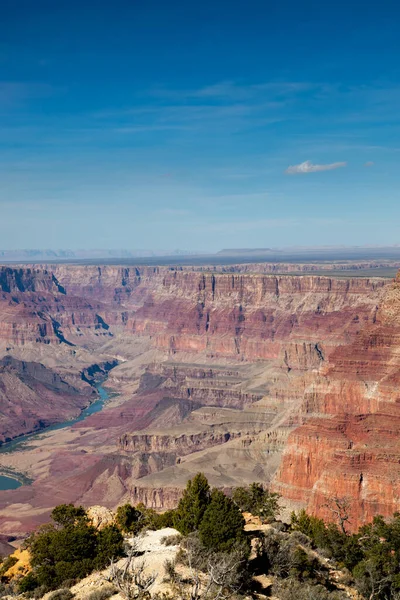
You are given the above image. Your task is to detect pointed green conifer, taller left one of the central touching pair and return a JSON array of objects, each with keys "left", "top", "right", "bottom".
[{"left": 174, "top": 473, "right": 211, "bottom": 535}]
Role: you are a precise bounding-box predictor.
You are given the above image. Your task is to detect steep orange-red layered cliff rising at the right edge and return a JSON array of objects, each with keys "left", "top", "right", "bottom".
[{"left": 276, "top": 278, "right": 400, "bottom": 529}]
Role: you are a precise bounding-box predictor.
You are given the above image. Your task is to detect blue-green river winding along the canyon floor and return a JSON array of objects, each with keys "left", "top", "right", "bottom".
[{"left": 0, "top": 384, "right": 109, "bottom": 491}]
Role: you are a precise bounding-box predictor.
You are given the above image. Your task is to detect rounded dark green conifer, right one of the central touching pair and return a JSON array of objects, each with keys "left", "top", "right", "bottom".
[{"left": 199, "top": 489, "right": 245, "bottom": 552}]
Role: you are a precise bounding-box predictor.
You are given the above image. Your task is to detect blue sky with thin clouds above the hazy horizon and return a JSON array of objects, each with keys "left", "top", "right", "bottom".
[{"left": 0, "top": 0, "right": 400, "bottom": 251}]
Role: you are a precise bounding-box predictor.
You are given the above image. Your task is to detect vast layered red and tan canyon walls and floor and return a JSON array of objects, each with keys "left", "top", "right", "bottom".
[{"left": 0, "top": 265, "right": 400, "bottom": 535}]
